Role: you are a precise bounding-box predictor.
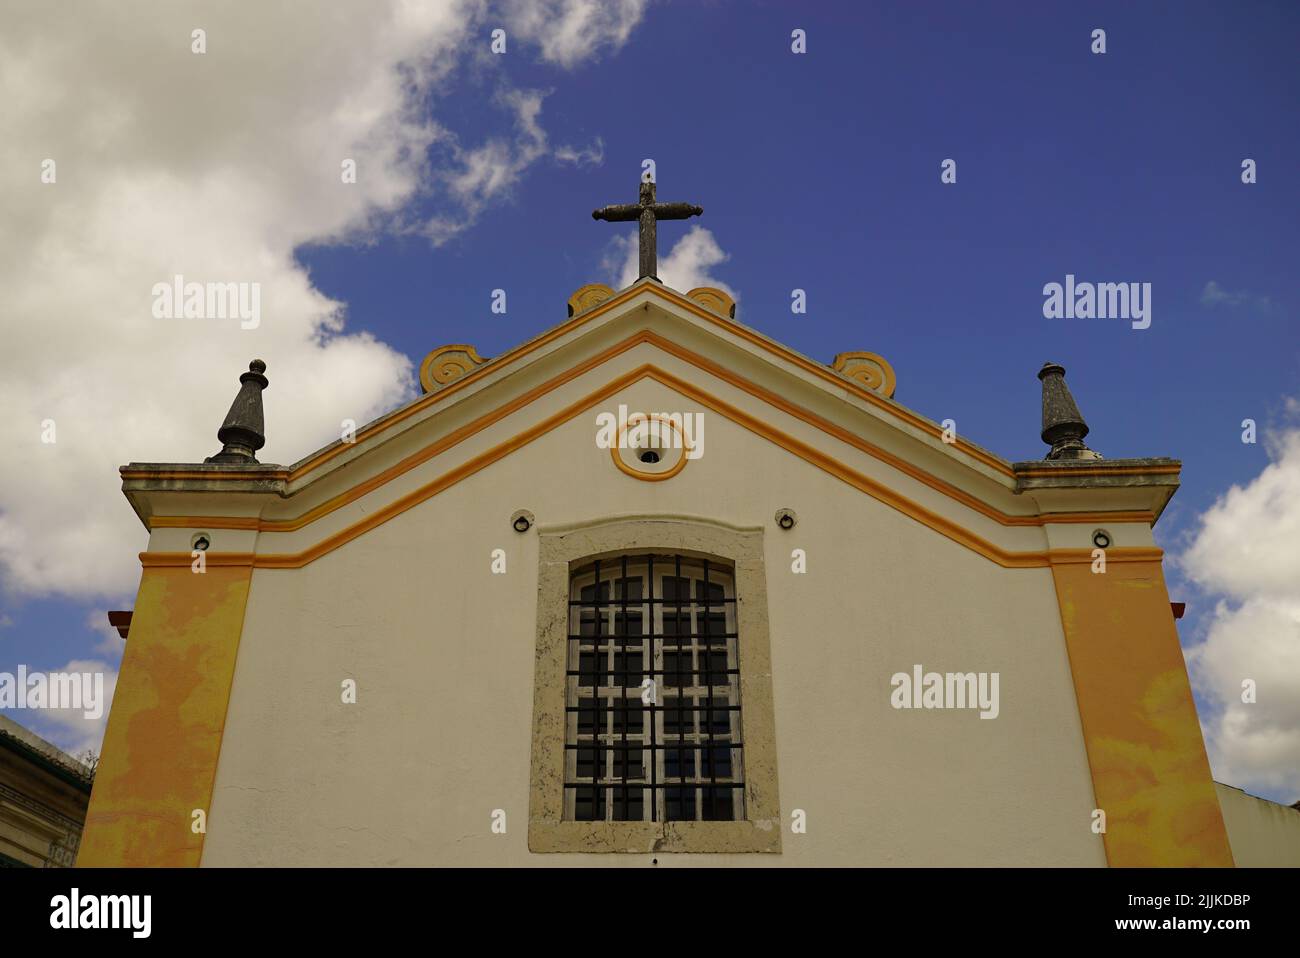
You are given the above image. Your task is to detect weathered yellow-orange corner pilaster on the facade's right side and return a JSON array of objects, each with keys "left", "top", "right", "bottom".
[{"left": 1052, "top": 562, "right": 1232, "bottom": 868}]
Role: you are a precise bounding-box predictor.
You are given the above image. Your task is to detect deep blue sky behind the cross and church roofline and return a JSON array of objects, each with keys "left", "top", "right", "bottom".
[{"left": 0, "top": 3, "right": 1300, "bottom": 801}]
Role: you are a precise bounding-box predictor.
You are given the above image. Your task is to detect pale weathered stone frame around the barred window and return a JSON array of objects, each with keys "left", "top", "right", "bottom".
[{"left": 528, "top": 516, "right": 781, "bottom": 854}]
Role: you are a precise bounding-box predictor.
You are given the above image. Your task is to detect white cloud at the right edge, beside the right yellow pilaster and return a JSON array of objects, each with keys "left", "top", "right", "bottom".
[{"left": 1179, "top": 426, "right": 1300, "bottom": 801}]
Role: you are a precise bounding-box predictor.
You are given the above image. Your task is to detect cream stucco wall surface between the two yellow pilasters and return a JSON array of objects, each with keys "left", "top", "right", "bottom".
[{"left": 203, "top": 354, "right": 1105, "bottom": 866}]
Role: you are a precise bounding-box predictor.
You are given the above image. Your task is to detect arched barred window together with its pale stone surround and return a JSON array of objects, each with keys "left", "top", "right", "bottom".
[{"left": 528, "top": 515, "right": 784, "bottom": 854}]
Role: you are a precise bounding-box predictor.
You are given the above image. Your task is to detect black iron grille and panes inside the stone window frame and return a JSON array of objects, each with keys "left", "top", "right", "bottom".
[{"left": 564, "top": 555, "right": 745, "bottom": 822}]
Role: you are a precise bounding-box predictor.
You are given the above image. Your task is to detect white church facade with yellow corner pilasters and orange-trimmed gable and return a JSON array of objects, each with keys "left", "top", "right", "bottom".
[{"left": 81, "top": 274, "right": 1234, "bottom": 867}]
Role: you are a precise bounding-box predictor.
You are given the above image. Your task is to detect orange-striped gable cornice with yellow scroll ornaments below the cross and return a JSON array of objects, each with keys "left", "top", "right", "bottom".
[{"left": 122, "top": 281, "right": 1177, "bottom": 567}]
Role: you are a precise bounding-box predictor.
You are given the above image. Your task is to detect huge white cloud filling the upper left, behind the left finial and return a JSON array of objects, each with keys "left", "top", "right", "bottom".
[{"left": 0, "top": 0, "right": 641, "bottom": 597}]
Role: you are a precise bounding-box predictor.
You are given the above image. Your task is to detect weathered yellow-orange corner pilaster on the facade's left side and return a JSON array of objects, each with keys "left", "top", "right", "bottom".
[{"left": 77, "top": 567, "right": 252, "bottom": 867}]
